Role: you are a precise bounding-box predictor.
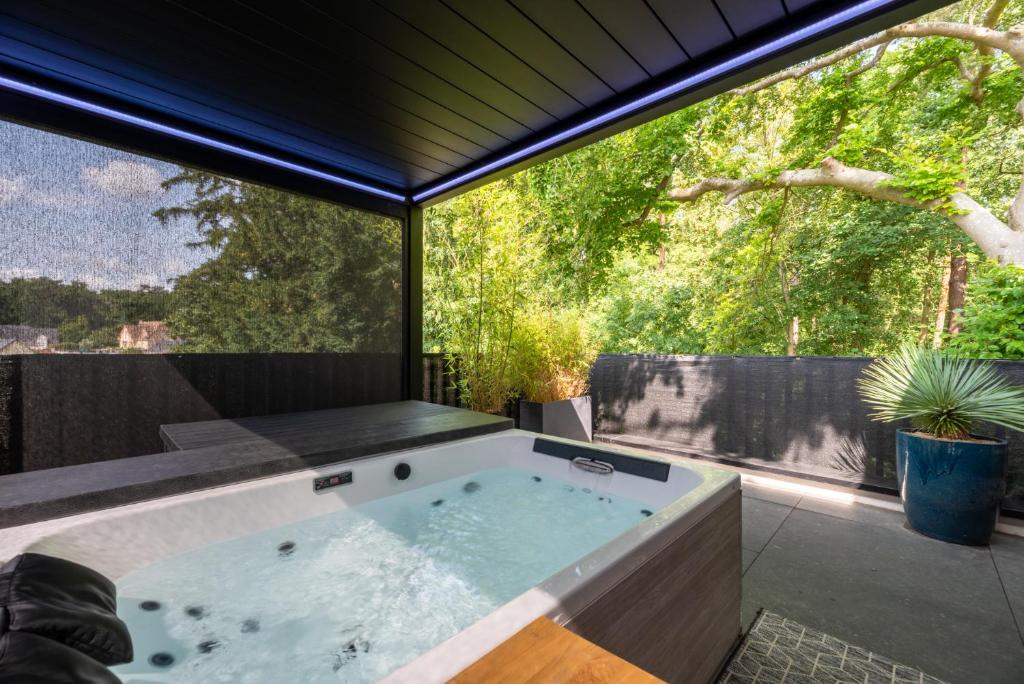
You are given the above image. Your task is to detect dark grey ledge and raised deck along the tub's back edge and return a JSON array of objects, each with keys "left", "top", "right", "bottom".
[{"left": 0, "top": 401, "right": 512, "bottom": 527}]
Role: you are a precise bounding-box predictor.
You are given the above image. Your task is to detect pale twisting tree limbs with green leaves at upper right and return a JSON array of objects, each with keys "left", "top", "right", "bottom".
[{"left": 667, "top": 0, "right": 1024, "bottom": 265}]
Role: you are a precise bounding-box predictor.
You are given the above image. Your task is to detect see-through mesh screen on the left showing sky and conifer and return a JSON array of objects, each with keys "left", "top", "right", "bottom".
[{"left": 0, "top": 122, "right": 401, "bottom": 353}]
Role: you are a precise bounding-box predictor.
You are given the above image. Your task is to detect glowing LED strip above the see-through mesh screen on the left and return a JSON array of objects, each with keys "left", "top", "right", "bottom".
[{"left": 0, "top": 76, "right": 408, "bottom": 203}]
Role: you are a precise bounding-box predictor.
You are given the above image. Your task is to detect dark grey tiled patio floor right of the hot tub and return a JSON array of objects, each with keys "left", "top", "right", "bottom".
[{"left": 742, "top": 478, "right": 1024, "bottom": 684}]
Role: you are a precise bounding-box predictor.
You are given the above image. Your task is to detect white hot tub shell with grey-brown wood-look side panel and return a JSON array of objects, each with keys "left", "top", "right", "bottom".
[{"left": 0, "top": 430, "right": 741, "bottom": 684}]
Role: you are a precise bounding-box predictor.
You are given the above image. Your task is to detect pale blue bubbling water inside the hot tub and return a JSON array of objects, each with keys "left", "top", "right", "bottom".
[{"left": 114, "top": 468, "right": 647, "bottom": 684}]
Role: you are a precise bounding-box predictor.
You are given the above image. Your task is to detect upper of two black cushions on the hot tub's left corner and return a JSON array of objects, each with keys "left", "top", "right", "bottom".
[{"left": 0, "top": 553, "right": 132, "bottom": 663}]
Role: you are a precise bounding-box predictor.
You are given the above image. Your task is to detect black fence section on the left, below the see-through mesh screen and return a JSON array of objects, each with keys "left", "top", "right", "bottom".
[{"left": 0, "top": 353, "right": 401, "bottom": 473}]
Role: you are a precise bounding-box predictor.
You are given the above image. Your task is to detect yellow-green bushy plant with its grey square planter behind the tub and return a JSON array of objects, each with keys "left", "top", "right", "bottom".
[{"left": 515, "top": 310, "right": 597, "bottom": 441}]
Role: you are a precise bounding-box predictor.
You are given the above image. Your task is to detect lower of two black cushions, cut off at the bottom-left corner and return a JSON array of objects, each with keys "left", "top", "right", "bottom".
[{"left": 0, "top": 632, "right": 121, "bottom": 684}]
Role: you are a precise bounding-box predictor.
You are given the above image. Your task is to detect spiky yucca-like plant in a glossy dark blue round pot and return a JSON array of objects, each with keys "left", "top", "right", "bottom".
[{"left": 859, "top": 347, "right": 1024, "bottom": 545}]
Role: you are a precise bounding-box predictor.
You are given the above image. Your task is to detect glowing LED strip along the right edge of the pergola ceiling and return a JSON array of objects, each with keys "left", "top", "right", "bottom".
[{"left": 413, "top": 0, "right": 898, "bottom": 203}]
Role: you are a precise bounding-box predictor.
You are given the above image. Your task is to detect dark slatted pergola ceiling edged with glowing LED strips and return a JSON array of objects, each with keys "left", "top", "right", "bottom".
[{"left": 0, "top": 0, "right": 944, "bottom": 202}]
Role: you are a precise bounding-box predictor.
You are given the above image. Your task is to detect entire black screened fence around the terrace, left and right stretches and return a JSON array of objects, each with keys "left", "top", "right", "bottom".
[{"left": 8, "top": 353, "right": 1024, "bottom": 512}]
